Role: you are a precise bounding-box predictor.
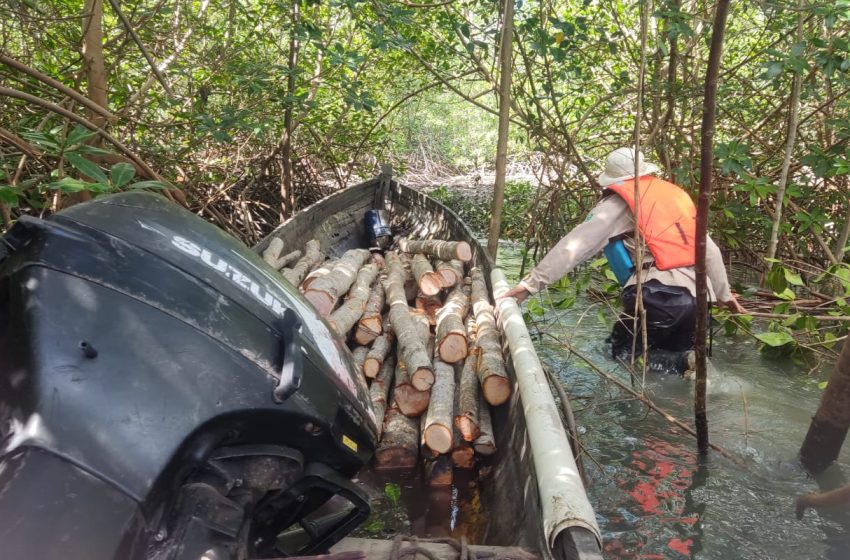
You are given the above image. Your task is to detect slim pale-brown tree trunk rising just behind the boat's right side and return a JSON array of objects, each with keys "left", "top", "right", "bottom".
[{"left": 487, "top": 0, "right": 514, "bottom": 261}]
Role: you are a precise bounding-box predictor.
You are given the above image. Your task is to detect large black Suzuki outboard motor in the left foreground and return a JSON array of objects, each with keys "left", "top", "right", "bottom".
[{"left": 0, "top": 193, "right": 376, "bottom": 560}]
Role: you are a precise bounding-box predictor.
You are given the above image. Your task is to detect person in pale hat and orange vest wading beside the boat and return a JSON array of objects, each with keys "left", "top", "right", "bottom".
[{"left": 501, "top": 148, "right": 746, "bottom": 359}]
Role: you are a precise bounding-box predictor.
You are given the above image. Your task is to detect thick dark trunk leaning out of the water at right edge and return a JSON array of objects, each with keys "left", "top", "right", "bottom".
[{"left": 800, "top": 340, "right": 850, "bottom": 474}]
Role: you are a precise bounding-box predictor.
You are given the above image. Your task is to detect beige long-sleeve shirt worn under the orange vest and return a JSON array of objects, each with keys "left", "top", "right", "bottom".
[{"left": 520, "top": 195, "right": 732, "bottom": 302}]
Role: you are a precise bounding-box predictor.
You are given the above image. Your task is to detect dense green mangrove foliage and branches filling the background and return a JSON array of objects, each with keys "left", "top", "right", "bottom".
[{"left": 0, "top": 0, "right": 850, "bottom": 352}]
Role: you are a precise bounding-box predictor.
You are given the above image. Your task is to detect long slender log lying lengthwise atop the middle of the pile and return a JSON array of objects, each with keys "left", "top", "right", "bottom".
[{"left": 386, "top": 251, "right": 434, "bottom": 391}]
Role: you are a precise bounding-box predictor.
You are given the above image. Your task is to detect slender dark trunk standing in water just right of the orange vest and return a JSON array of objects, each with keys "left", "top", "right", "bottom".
[{"left": 694, "top": 0, "right": 729, "bottom": 452}]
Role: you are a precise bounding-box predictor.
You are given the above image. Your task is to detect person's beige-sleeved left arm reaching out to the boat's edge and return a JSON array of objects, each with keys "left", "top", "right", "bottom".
[{"left": 500, "top": 196, "right": 634, "bottom": 303}]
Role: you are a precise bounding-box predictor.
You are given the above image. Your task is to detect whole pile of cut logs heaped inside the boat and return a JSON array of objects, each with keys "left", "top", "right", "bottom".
[{"left": 263, "top": 234, "right": 511, "bottom": 486}]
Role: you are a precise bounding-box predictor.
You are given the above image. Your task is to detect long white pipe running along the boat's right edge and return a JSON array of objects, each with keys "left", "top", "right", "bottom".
[{"left": 490, "top": 268, "right": 602, "bottom": 547}]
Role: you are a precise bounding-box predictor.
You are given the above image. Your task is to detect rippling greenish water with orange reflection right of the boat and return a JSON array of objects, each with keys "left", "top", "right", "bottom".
[{"left": 499, "top": 241, "right": 850, "bottom": 559}]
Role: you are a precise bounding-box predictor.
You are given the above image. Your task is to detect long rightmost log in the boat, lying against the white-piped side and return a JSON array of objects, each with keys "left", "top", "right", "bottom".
[{"left": 470, "top": 267, "right": 511, "bottom": 406}]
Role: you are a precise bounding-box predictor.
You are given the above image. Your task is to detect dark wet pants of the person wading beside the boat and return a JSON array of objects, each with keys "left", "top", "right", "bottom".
[{"left": 611, "top": 280, "right": 696, "bottom": 360}]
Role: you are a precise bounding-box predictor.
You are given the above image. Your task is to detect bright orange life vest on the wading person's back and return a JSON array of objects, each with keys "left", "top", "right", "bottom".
[{"left": 607, "top": 176, "right": 697, "bottom": 270}]
